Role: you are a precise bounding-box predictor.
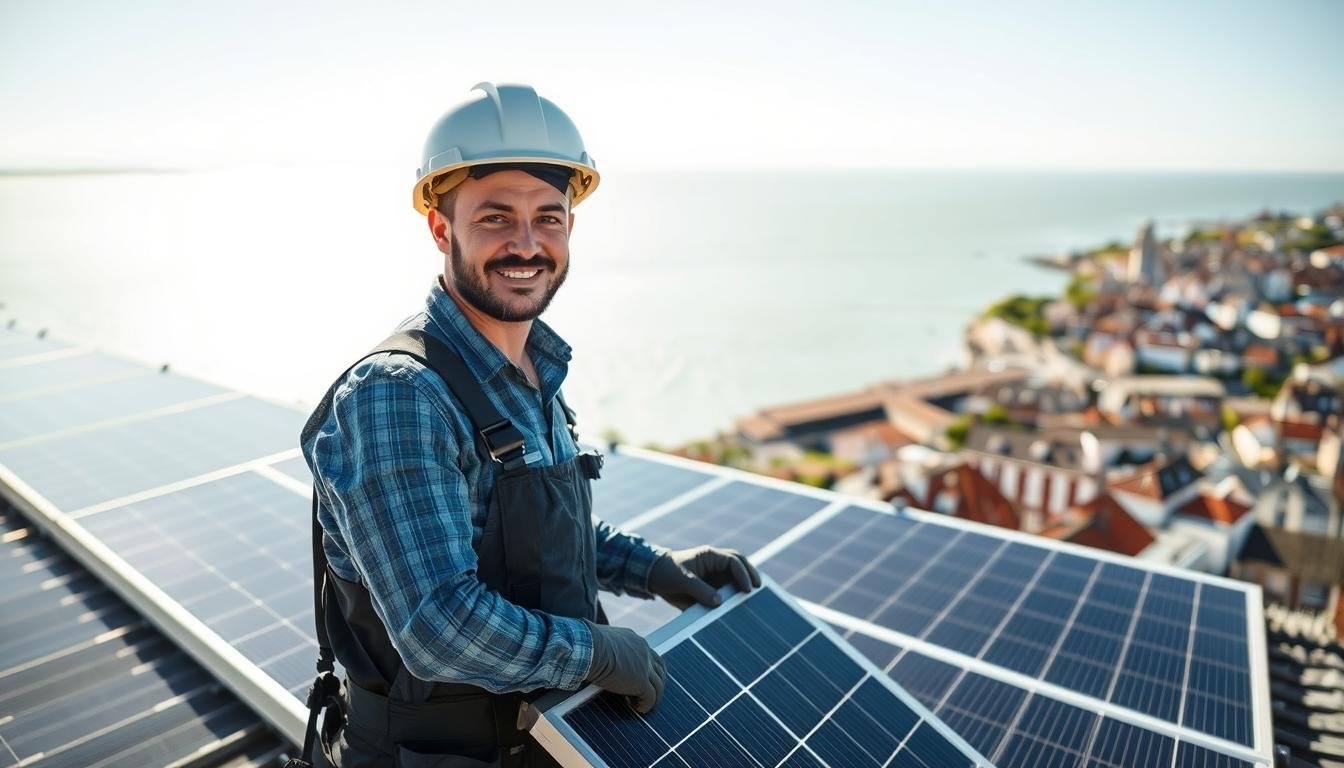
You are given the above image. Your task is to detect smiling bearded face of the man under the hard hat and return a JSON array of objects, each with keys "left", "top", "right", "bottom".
[{"left": 429, "top": 171, "right": 574, "bottom": 323}]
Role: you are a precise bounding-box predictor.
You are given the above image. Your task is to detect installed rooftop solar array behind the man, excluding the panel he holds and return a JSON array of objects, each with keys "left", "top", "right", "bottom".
[{"left": 0, "top": 325, "right": 1271, "bottom": 767}]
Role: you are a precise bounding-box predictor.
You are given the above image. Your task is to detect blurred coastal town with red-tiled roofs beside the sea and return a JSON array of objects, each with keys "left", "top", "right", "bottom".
[{"left": 675, "top": 204, "right": 1344, "bottom": 764}]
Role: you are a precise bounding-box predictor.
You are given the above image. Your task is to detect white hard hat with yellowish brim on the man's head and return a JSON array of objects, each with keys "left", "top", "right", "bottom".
[{"left": 411, "top": 82, "right": 598, "bottom": 214}]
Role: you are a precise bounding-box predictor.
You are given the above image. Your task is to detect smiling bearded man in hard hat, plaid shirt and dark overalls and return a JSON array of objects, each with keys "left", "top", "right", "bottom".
[{"left": 292, "top": 83, "right": 759, "bottom": 768}]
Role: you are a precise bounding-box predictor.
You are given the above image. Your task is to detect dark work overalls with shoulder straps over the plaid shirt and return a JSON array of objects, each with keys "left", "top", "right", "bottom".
[{"left": 294, "top": 330, "right": 605, "bottom": 768}]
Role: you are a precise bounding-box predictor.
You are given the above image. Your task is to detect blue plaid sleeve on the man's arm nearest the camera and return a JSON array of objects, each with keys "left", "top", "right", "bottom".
[{"left": 310, "top": 369, "right": 593, "bottom": 693}]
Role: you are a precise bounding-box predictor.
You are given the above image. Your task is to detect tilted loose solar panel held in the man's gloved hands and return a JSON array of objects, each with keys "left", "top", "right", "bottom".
[{"left": 532, "top": 580, "right": 989, "bottom": 768}]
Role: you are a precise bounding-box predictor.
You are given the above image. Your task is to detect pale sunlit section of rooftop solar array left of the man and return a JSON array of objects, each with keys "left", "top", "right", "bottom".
[{"left": 0, "top": 331, "right": 317, "bottom": 741}]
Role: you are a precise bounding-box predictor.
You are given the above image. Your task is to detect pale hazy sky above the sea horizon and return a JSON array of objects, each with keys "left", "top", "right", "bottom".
[{"left": 0, "top": 0, "right": 1344, "bottom": 176}]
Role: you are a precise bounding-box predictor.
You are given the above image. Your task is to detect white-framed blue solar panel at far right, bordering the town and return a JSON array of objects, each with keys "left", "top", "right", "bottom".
[{"left": 763, "top": 507, "right": 1254, "bottom": 746}]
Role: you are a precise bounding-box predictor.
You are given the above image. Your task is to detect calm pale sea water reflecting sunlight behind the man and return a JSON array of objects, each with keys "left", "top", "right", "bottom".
[{"left": 0, "top": 168, "right": 1344, "bottom": 444}]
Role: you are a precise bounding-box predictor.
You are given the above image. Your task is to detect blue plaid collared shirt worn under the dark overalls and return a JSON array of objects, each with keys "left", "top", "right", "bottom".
[{"left": 302, "top": 281, "right": 663, "bottom": 691}]
